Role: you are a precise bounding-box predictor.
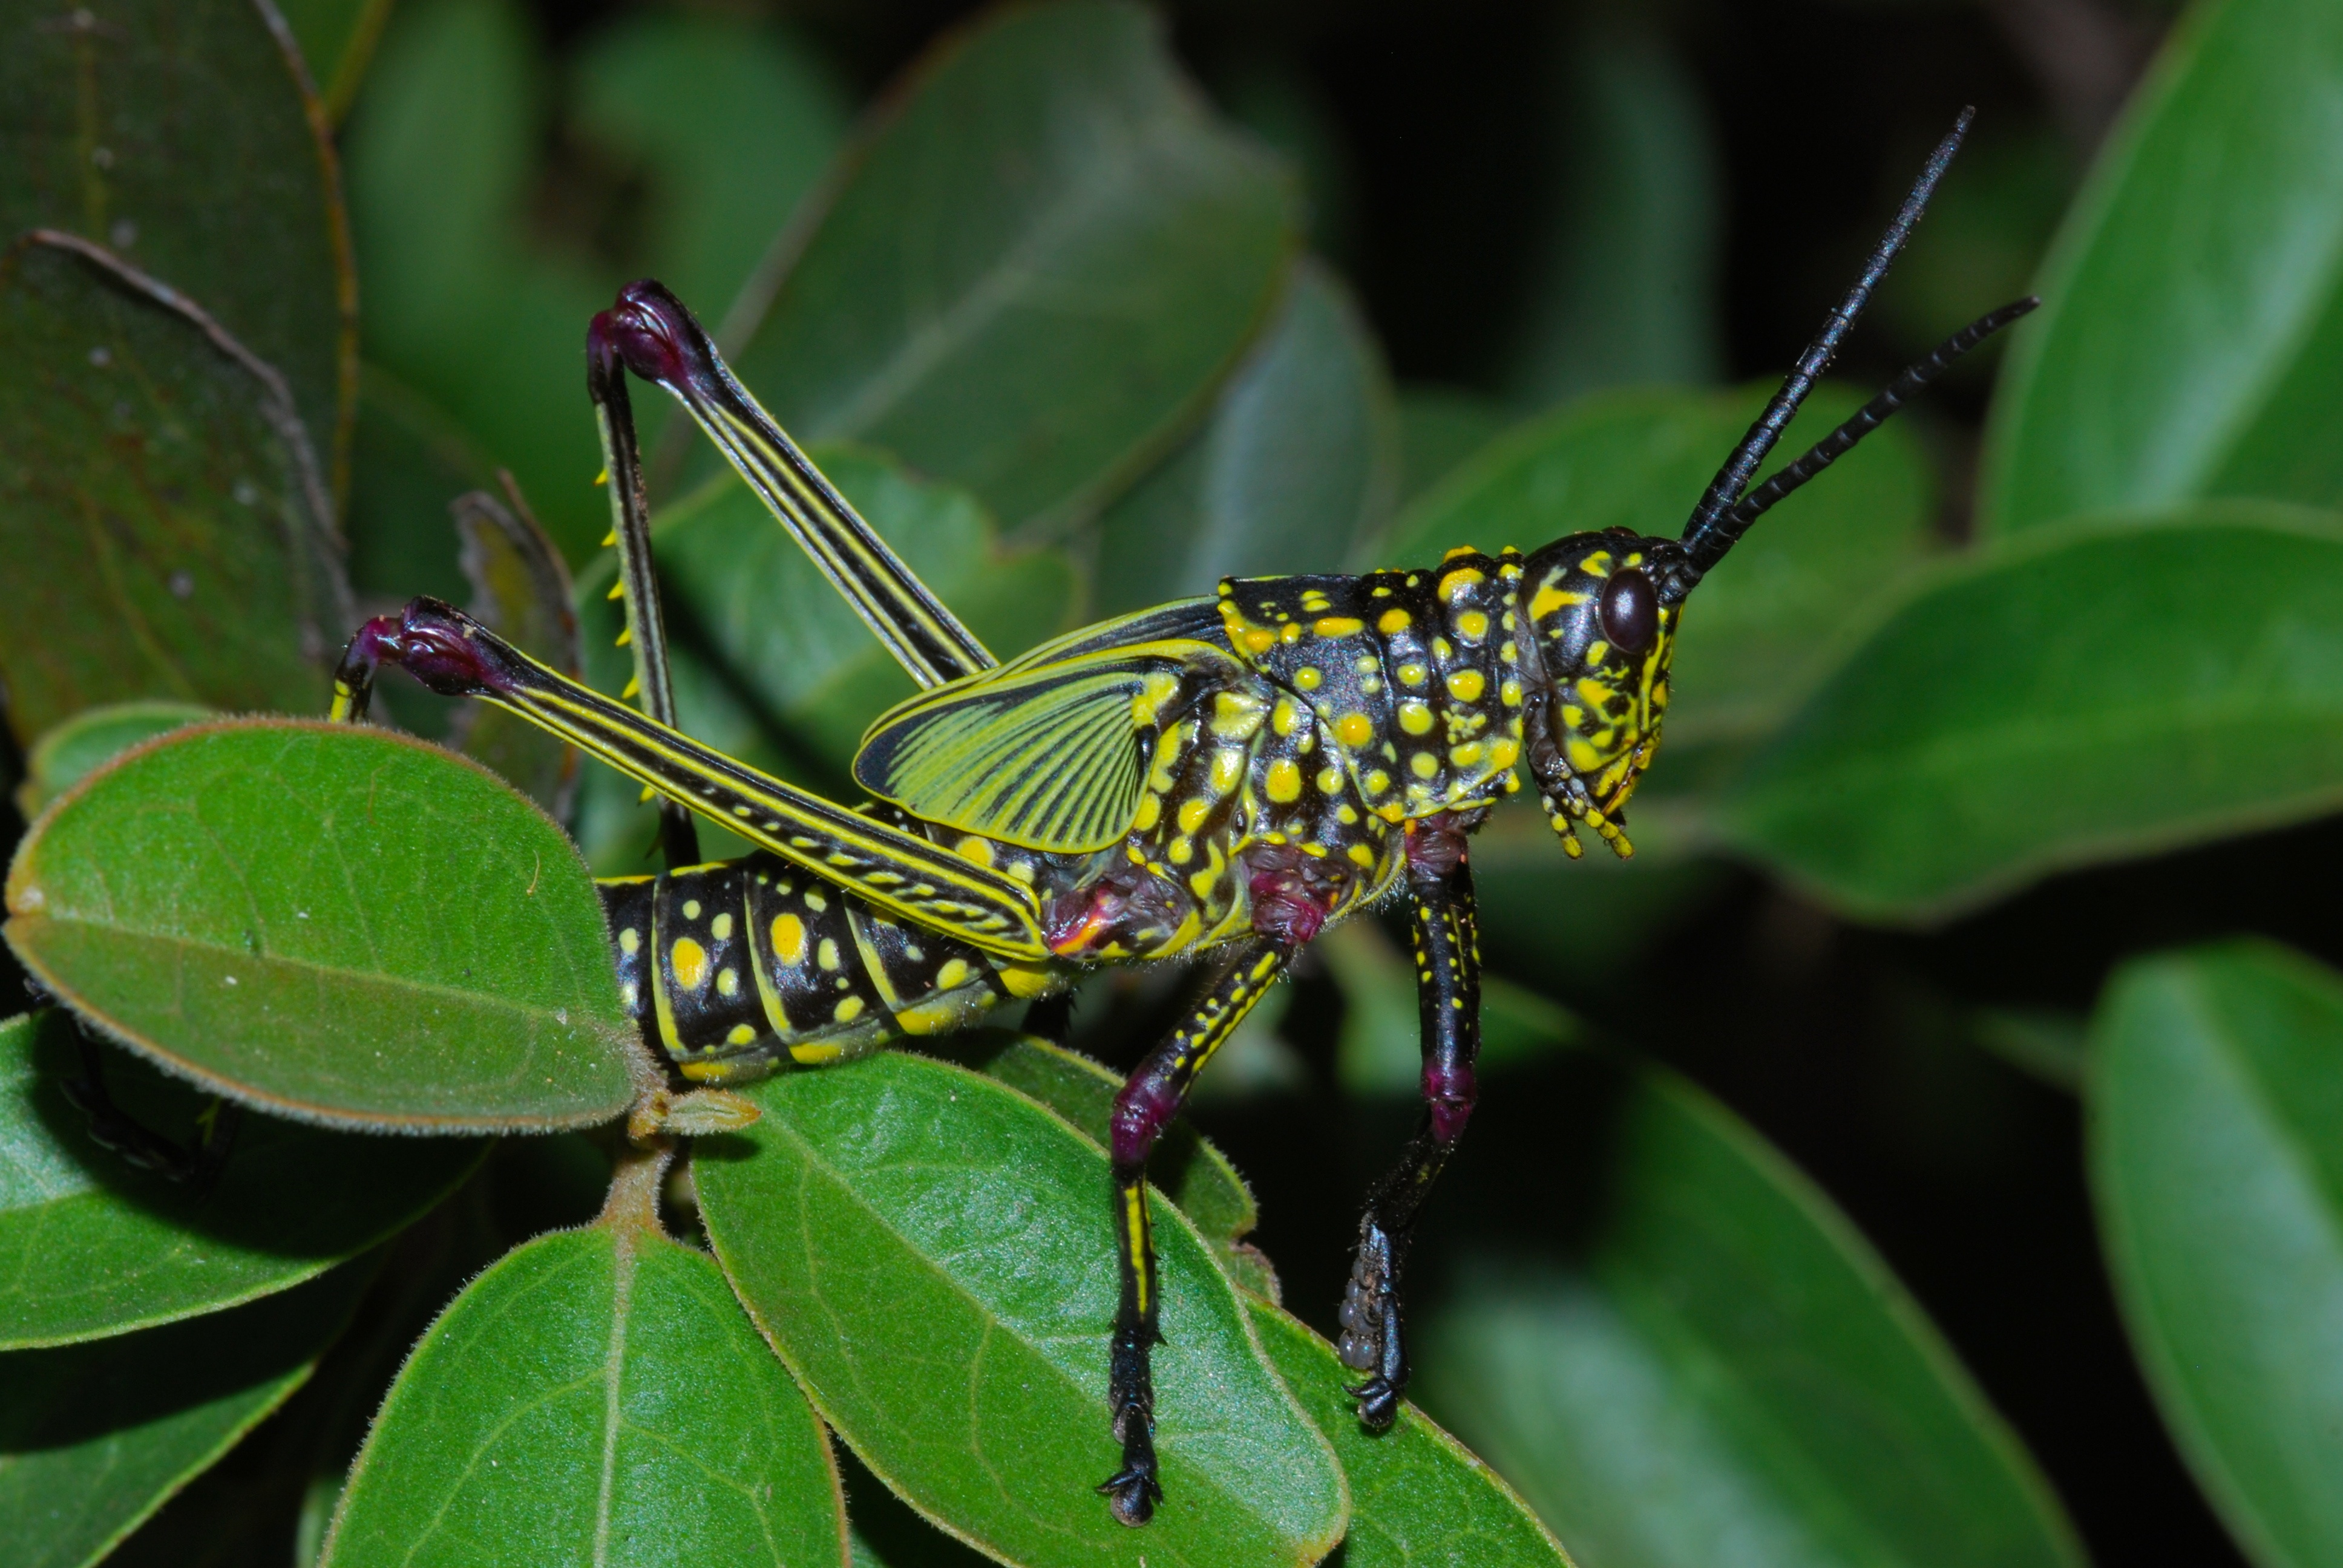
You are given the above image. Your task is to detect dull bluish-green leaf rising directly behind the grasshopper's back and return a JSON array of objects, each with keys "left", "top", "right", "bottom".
[{"left": 1096, "top": 260, "right": 1399, "bottom": 614}]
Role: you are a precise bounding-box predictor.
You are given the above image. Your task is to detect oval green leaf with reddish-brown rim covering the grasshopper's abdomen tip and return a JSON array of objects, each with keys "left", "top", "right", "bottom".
[{"left": 5, "top": 722, "right": 637, "bottom": 1132}]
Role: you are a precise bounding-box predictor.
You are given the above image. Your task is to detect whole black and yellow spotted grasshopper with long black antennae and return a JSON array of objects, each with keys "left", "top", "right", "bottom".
[{"left": 333, "top": 113, "right": 2034, "bottom": 1526}]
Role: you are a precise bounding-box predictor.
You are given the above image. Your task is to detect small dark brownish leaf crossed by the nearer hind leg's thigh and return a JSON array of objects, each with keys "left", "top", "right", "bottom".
[{"left": 454, "top": 485, "right": 578, "bottom": 820}]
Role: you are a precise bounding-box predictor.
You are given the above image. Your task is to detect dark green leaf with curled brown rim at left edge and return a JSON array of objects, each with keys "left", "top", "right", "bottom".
[{"left": 0, "top": 244, "right": 352, "bottom": 743}]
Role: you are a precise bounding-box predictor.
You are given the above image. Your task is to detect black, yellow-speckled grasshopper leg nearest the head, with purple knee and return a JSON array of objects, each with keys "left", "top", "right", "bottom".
[{"left": 1338, "top": 818, "right": 1481, "bottom": 1432}]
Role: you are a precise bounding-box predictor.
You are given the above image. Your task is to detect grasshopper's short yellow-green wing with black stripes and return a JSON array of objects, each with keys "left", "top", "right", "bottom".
[{"left": 855, "top": 656, "right": 1162, "bottom": 853}]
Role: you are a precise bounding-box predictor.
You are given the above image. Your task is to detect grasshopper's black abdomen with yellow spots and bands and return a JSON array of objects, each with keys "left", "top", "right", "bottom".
[{"left": 600, "top": 853, "right": 1071, "bottom": 1083}]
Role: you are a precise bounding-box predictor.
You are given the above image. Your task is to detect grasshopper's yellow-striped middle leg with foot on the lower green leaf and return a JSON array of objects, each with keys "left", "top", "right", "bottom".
[{"left": 1099, "top": 938, "right": 1293, "bottom": 1523}]
